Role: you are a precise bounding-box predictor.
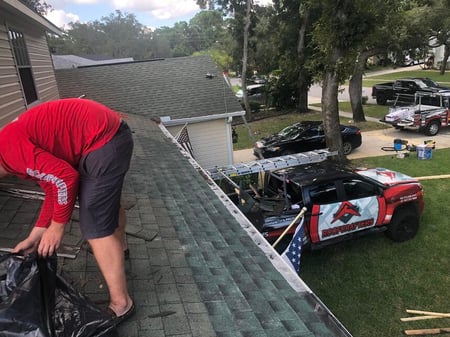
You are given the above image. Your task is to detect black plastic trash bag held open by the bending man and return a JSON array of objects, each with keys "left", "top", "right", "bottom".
[{"left": 0, "top": 254, "right": 118, "bottom": 337}]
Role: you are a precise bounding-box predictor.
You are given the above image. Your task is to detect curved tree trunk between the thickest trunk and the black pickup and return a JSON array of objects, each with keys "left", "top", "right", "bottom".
[{"left": 348, "top": 52, "right": 368, "bottom": 122}]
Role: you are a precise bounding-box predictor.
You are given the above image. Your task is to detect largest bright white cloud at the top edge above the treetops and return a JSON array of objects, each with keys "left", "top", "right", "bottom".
[{"left": 113, "top": 0, "right": 199, "bottom": 20}]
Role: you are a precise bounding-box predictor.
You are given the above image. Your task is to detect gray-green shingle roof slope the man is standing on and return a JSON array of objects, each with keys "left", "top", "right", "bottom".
[{"left": 0, "top": 115, "right": 352, "bottom": 337}]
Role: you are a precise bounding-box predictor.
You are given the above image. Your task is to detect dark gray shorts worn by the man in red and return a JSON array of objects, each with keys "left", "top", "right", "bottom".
[{"left": 78, "top": 122, "right": 133, "bottom": 240}]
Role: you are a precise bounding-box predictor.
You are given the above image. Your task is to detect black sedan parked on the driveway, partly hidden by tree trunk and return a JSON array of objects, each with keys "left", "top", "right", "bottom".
[{"left": 253, "top": 121, "right": 362, "bottom": 158}]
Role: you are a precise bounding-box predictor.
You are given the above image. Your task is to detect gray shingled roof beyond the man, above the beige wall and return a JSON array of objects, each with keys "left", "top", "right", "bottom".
[{"left": 56, "top": 56, "right": 243, "bottom": 120}]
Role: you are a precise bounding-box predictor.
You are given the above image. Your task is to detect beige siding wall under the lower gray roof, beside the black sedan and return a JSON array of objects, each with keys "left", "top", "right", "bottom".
[{"left": 167, "top": 118, "right": 233, "bottom": 169}]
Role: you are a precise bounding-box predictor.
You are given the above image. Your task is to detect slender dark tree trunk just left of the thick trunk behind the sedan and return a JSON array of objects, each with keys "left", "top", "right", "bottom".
[{"left": 297, "top": 3, "right": 309, "bottom": 113}]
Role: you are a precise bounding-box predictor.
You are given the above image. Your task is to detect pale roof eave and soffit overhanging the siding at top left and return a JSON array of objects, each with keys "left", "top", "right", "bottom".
[{"left": 0, "top": 0, "right": 62, "bottom": 35}]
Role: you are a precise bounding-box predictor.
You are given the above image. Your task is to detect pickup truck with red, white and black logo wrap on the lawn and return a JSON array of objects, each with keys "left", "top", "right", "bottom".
[{"left": 232, "top": 162, "right": 424, "bottom": 249}]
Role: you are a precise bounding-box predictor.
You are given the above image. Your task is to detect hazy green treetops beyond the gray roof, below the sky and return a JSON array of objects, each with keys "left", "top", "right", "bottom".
[{"left": 50, "top": 11, "right": 230, "bottom": 63}]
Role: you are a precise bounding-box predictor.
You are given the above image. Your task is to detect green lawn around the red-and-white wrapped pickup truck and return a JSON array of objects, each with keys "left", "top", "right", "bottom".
[{"left": 300, "top": 149, "right": 450, "bottom": 337}]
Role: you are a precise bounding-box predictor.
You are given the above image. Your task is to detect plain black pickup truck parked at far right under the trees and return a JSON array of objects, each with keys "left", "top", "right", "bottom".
[{"left": 372, "top": 78, "right": 450, "bottom": 105}]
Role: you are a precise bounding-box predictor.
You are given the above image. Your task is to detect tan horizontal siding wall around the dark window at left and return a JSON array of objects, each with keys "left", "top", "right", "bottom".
[{"left": 0, "top": 13, "right": 59, "bottom": 127}]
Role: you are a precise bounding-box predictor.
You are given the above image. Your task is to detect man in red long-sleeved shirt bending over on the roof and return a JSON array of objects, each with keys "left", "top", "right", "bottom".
[{"left": 0, "top": 98, "right": 134, "bottom": 324}]
